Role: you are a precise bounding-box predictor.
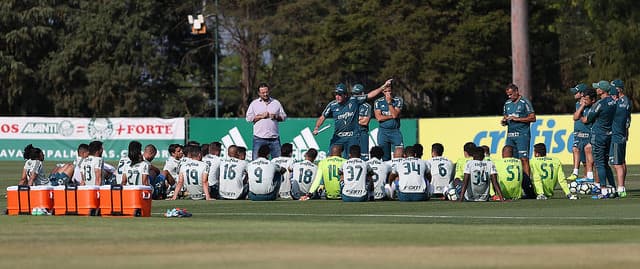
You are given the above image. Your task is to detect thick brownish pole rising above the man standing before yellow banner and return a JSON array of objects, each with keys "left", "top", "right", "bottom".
[{"left": 511, "top": 0, "right": 531, "bottom": 99}]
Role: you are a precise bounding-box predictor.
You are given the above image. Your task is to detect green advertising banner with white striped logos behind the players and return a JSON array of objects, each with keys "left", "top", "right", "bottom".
[{"left": 188, "top": 118, "right": 417, "bottom": 160}]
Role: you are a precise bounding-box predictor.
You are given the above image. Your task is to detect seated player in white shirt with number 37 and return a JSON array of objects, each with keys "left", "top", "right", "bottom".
[{"left": 340, "top": 145, "right": 373, "bottom": 202}]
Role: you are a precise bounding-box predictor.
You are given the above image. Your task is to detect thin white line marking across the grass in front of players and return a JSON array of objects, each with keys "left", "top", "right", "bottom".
[{"left": 153, "top": 212, "right": 640, "bottom": 220}]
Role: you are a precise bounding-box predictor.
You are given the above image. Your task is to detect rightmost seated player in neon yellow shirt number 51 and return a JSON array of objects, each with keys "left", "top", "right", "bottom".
[{"left": 531, "top": 143, "right": 577, "bottom": 200}]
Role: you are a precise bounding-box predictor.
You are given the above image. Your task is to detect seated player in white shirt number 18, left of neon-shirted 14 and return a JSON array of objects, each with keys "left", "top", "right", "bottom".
[{"left": 291, "top": 149, "right": 320, "bottom": 200}]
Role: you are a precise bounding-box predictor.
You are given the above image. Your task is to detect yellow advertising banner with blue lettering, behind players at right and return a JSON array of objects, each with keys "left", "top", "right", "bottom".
[{"left": 418, "top": 114, "right": 640, "bottom": 165}]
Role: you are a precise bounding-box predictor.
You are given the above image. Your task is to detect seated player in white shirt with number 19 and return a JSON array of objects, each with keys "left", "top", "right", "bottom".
[{"left": 171, "top": 142, "right": 211, "bottom": 200}]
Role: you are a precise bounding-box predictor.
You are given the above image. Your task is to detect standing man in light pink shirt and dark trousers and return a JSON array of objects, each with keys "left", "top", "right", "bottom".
[{"left": 247, "top": 83, "right": 287, "bottom": 159}]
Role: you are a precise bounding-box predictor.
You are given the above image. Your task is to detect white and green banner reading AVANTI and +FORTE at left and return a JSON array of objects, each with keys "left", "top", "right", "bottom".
[{"left": 0, "top": 117, "right": 185, "bottom": 161}]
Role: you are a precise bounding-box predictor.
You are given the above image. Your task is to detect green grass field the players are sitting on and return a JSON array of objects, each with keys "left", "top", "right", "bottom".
[{"left": 0, "top": 162, "right": 640, "bottom": 268}]
